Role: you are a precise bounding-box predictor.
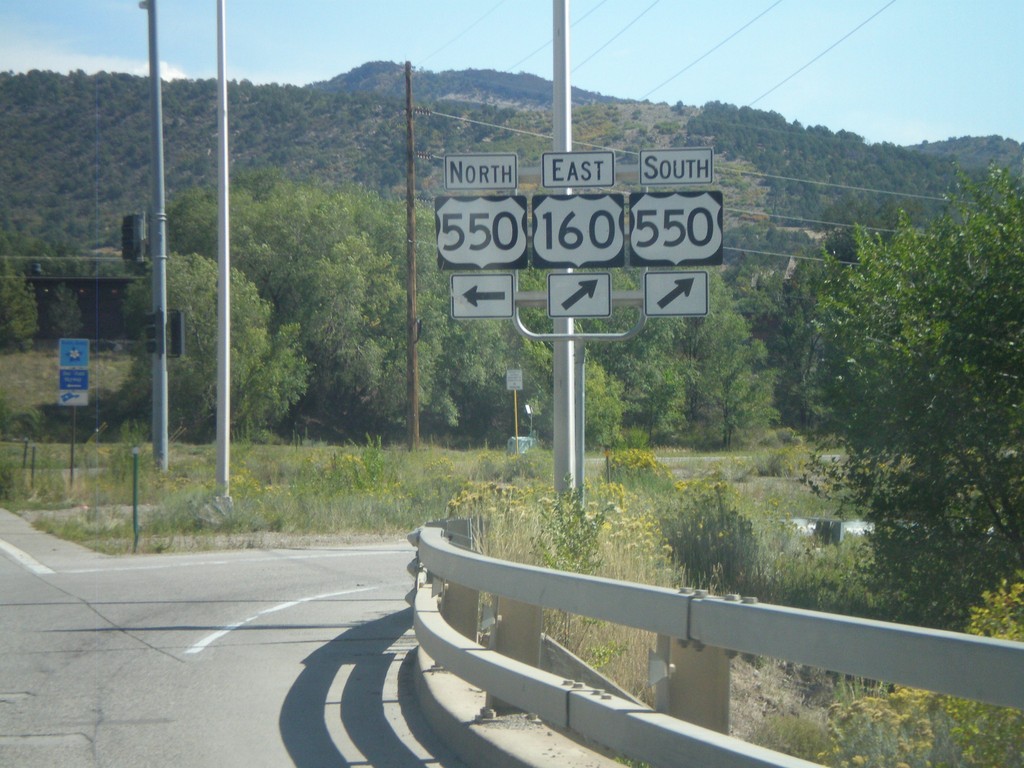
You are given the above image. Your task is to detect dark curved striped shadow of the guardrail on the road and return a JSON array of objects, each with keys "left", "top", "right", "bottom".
[{"left": 279, "top": 608, "right": 461, "bottom": 768}]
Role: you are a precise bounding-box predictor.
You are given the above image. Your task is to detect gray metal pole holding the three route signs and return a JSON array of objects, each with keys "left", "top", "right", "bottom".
[{"left": 552, "top": 0, "right": 578, "bottom": 492}]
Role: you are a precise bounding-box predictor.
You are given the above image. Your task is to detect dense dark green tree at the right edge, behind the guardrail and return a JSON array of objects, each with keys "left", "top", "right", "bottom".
[{"left": 820, "top": 170, "right": 1024, "bottom": 627}]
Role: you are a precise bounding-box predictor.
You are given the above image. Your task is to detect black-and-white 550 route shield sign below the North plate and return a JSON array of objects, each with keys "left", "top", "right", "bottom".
[{"left": 434, "top": 196, "right": 528, "bottom": 269}]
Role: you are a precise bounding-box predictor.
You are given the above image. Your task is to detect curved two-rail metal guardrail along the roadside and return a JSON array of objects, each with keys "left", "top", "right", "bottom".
[{"left": 410, "top": 527, "right": 1024, "bottom": 768}]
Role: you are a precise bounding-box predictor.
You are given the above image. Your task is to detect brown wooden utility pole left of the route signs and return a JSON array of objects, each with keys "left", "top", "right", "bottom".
[{"left": 406, "top": 61, "right": 420, "bottom": 451}]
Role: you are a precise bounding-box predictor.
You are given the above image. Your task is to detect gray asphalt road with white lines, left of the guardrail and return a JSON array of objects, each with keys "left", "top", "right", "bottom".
[{"left": 0, "top": 510, "right": 468, "bottom": 768}]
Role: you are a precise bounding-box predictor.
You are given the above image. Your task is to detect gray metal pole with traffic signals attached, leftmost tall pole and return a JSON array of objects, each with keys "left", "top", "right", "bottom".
[{"left": 139, "top": 0, "right": 168, "bottom": 472}]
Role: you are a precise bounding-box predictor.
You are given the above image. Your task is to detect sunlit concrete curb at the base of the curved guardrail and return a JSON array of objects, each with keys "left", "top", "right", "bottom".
[{"left": 415, "top": 647, "right": 622, "bottom": 768}]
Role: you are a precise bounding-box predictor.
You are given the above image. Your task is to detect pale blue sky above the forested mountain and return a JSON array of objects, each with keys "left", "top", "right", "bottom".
[{"left": 0, "top": 0, "right": 1024, "bottom": 144}]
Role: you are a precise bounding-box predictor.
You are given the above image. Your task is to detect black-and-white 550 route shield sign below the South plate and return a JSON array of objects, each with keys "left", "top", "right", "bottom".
[{"left": 630, "top": 191, "right": 724, "bottom": 266}]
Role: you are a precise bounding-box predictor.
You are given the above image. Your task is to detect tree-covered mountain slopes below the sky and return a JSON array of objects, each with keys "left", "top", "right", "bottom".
[{"left": 0, "top": 62, "right": 1020, "bottom": 253}]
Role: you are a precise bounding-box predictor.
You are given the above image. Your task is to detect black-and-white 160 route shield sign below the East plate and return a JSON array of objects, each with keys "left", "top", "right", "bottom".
[{"left": 534, "top": 195, "right": 626, "bottom": 269}]
